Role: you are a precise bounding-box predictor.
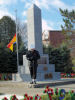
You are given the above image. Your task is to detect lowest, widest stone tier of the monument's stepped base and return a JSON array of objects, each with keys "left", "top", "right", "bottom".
[{"left": 12, "top": 72, "right": 60, "bottom": 82}]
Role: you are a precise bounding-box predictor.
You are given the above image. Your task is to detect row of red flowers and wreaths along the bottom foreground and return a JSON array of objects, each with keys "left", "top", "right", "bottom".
[{"left": 2, "top": 86, "right": 75, "bottom": 100}]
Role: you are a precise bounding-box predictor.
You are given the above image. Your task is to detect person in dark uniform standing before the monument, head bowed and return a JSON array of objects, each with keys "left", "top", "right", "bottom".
[{"left": 26, "top": 46, "right": 40, "bottom": 84}]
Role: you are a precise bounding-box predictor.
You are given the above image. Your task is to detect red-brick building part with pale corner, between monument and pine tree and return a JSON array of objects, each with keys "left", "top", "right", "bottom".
[{"left": 42, "top": 30, "right": 65, "bottom": 47}]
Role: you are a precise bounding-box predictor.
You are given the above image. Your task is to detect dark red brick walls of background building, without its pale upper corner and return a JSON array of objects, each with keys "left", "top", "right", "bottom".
[{"left": 43, "top": 30, "right": 75, "bottom": 57}]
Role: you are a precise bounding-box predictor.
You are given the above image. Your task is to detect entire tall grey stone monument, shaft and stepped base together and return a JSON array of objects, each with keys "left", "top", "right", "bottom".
[{"left": 12, "top": 4, "right": 60, "bottom": 81}]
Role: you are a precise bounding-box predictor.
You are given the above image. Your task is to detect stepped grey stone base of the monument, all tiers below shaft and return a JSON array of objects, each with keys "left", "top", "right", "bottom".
[{"left": 12, "top": 55, "right": 60, "bottom": 82}]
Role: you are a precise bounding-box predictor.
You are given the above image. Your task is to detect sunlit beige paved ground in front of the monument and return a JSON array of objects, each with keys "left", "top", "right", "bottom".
[{"left": 0, "top": 81, "right": 75, "bottom": 100}]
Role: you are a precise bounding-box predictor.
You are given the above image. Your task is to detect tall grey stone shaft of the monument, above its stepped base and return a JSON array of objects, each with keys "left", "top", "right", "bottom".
[{"left": 27, "top": 4, "right": 43, "bottom": 54}]
